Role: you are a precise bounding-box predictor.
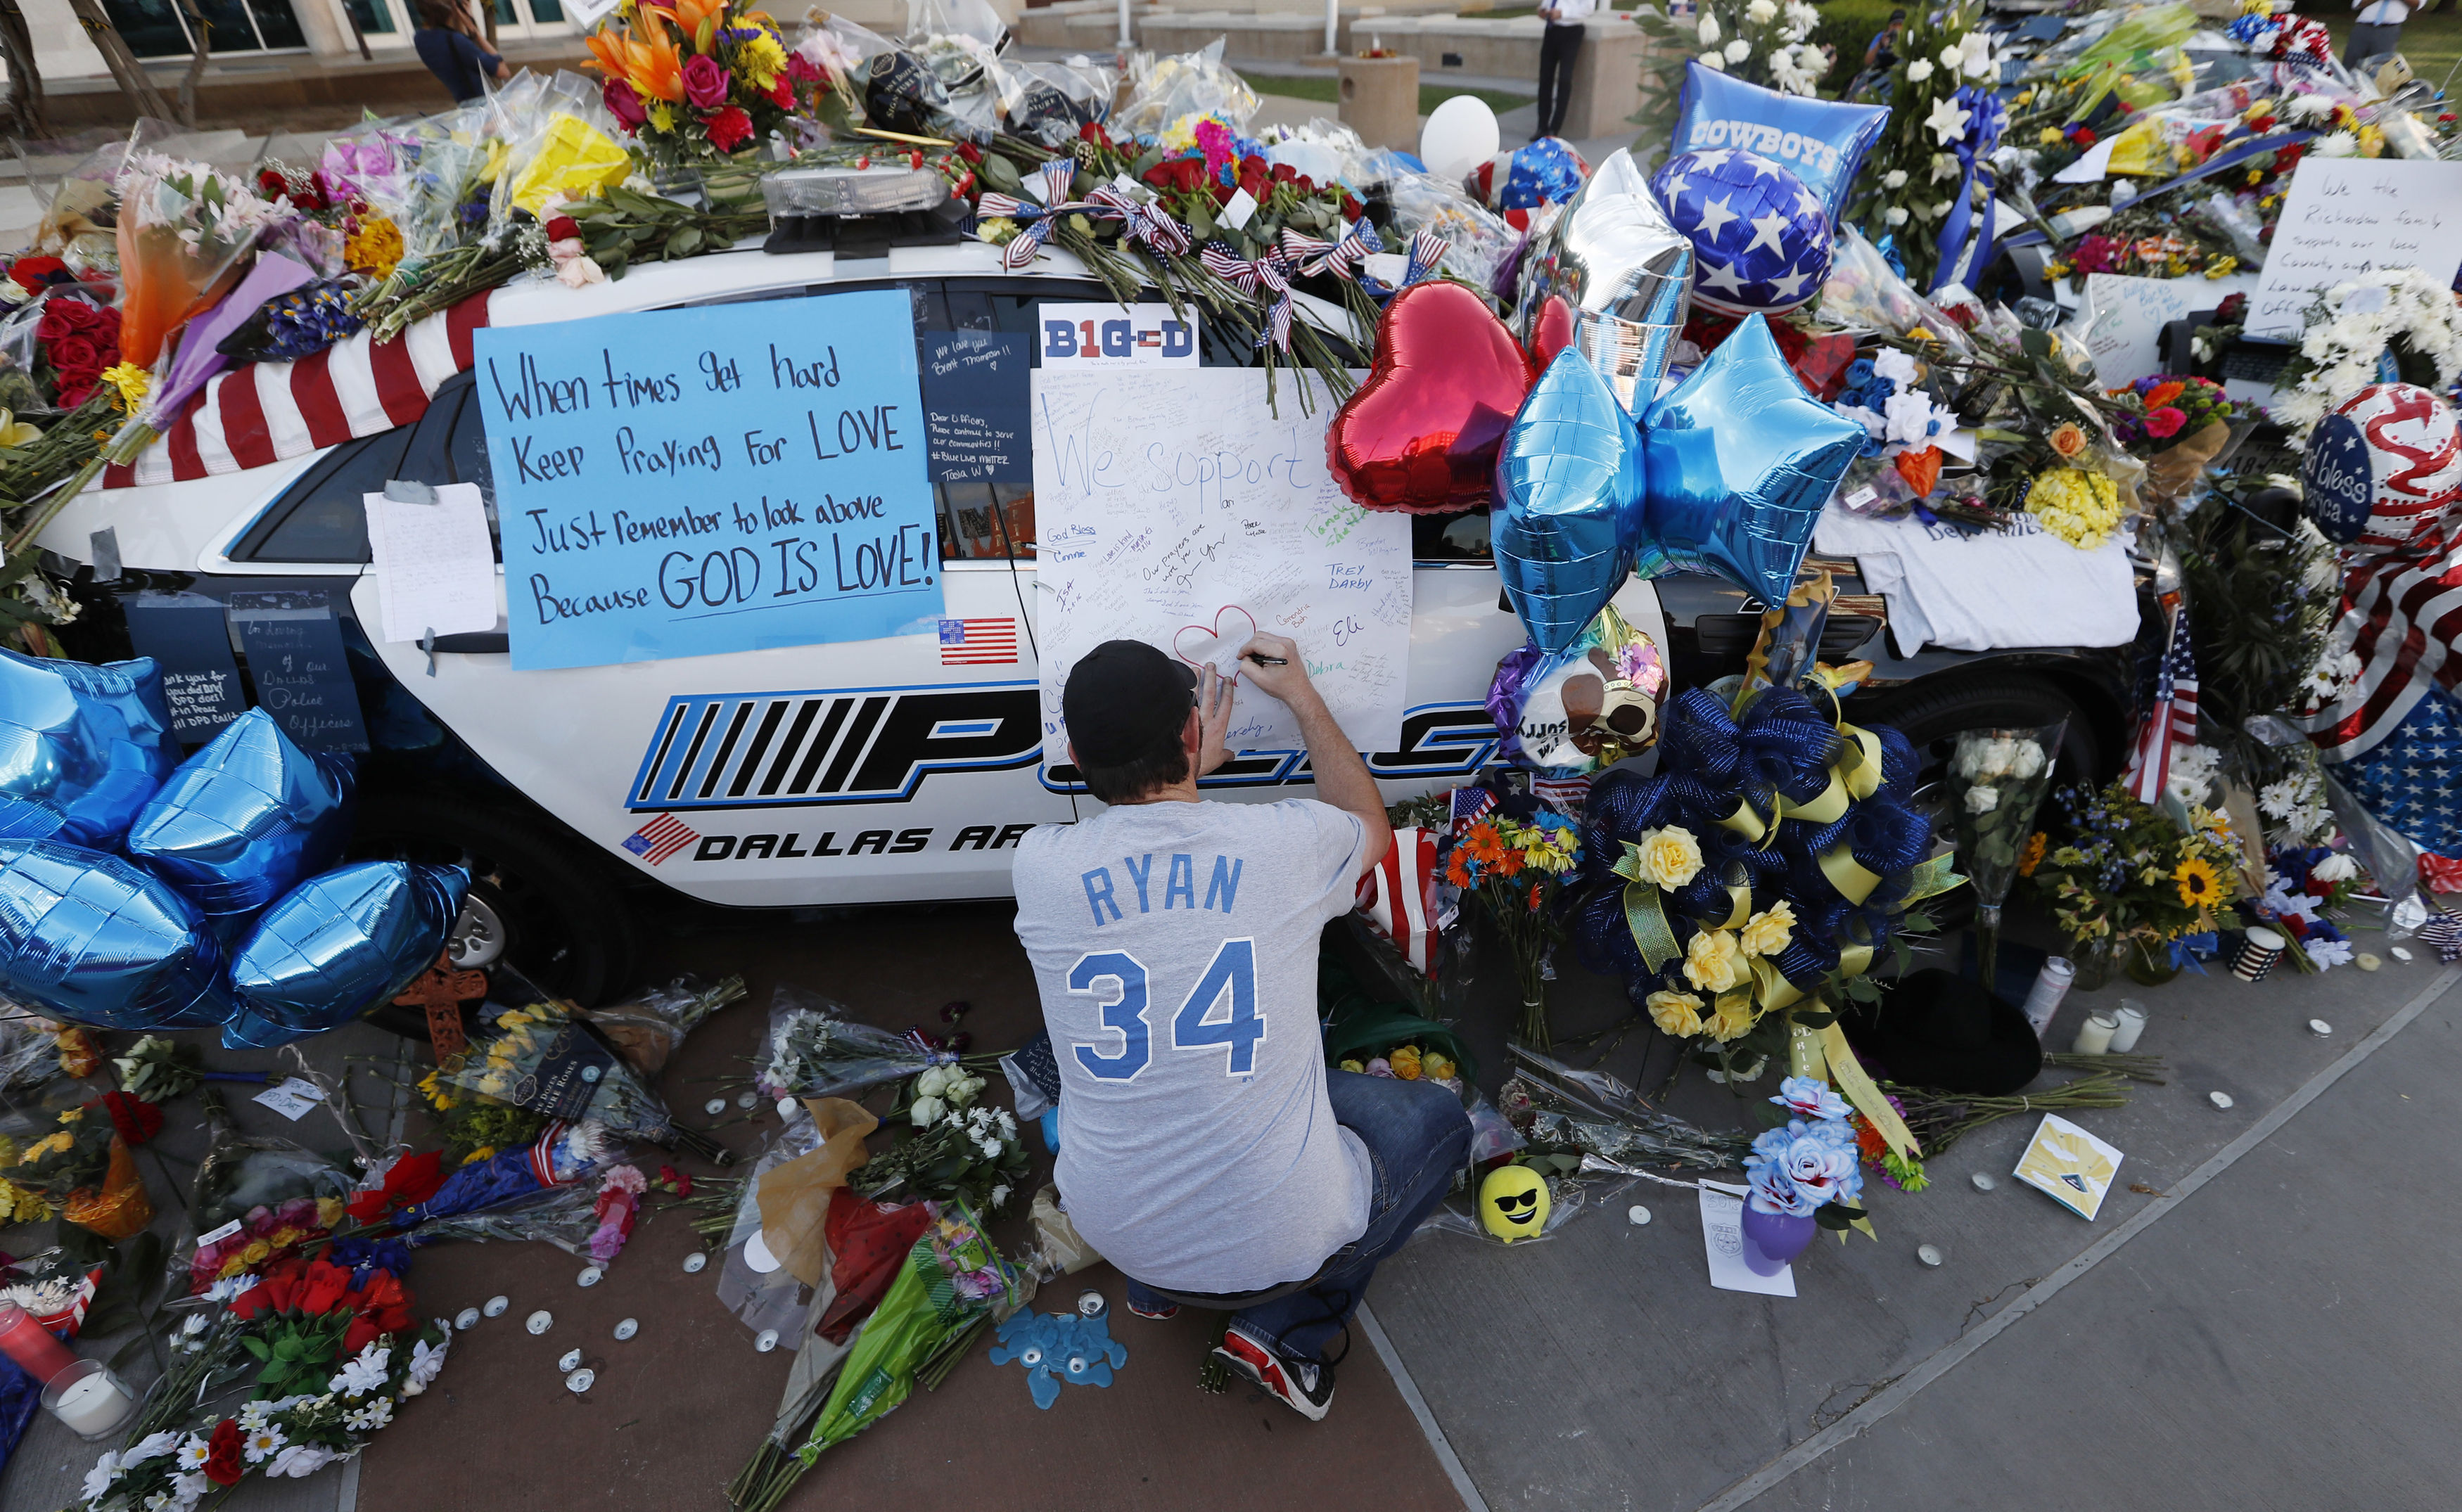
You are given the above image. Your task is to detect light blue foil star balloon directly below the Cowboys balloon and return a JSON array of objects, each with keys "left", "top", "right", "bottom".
[{"left": 1635, "top": 315, "right": 1864, "bottom": 603}]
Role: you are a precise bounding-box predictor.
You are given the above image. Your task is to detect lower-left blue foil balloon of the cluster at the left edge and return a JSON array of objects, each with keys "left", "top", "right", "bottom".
[{"left": 0, "top": 840, "right": 231, "bottom": 1030}]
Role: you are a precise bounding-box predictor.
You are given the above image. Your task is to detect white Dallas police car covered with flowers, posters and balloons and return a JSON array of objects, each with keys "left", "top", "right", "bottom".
[{"left": 42, "top": 244, "right": 2125, "bottom": 1000}]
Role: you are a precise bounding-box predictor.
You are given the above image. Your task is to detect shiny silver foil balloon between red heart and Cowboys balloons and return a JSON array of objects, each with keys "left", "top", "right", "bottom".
[{"left": 1514, "top": 148, "right": 1694, "bottom": 411}]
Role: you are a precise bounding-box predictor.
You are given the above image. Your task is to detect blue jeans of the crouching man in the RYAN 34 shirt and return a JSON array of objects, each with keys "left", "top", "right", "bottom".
[{"left": 1128, "top": 1071, "right": 1470, "bottom": 1359}]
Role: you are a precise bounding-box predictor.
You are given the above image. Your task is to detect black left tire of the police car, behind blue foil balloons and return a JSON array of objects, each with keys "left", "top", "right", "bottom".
[{"left": 352, "top": 793, "right": 635, "bottom": 1037}]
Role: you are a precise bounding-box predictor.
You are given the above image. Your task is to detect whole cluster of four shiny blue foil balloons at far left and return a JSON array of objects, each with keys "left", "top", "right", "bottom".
[{"left": 0, "top": 669, "right": 471, "bottom": 1046}]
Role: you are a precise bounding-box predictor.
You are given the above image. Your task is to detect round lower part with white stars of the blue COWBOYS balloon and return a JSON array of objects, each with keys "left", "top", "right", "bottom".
[{"left": 1650, "top": 148, "right": 1832, "bottom": 315}]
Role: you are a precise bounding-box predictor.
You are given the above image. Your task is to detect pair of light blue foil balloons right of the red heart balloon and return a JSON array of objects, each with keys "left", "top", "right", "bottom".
[{"left": 1490, "top": 315, "right": 1864, "bottom": 653}]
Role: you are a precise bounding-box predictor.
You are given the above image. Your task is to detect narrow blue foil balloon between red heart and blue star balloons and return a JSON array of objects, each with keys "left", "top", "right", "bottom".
[{"left": 1490, "top": 347, "right": 1645, "bottom": 653}]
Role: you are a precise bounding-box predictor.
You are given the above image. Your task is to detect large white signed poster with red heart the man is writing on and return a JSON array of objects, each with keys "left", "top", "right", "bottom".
[{"left": 1034, "top": 367, "right": 1411, "bottom": 764}]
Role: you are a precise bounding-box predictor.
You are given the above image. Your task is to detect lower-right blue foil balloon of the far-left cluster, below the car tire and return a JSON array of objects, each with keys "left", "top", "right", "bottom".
[{"left": 224, "top": 862, "right": 471, "bottom": 1049}]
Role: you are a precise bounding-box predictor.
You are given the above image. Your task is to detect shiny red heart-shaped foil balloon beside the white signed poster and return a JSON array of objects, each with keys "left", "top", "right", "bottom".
[{"left": 1325, "top": 283, "right": 1531, "bottom": 515}]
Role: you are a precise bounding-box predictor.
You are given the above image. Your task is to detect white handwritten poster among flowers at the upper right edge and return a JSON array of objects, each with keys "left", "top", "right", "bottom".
[{"left": 2248, "top": 158, "right": 2462, "bottom": 342}]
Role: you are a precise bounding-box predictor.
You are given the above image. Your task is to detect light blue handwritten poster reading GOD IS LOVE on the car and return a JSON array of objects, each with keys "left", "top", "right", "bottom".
[{"left": 473, "top": 290, "right": 940, "bottom": 669}]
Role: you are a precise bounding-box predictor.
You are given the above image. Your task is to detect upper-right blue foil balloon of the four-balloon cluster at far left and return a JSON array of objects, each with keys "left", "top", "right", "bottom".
[{"left": 128, "top": 709, "right": 355, "bottom": 923}]
